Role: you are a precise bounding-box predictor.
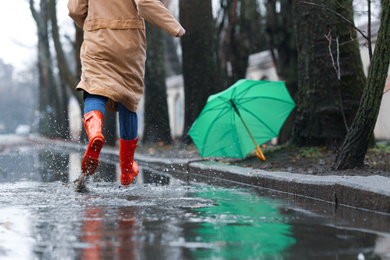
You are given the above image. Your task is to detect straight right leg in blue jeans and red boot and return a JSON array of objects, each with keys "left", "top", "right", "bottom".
[{"left": 118, "top": 103, "right": 139, "bottom": 185}]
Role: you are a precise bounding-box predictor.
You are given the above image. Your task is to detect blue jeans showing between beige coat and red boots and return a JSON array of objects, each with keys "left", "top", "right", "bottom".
[{"left": 84, "top": 92, "right": 138, "bottom": 140}]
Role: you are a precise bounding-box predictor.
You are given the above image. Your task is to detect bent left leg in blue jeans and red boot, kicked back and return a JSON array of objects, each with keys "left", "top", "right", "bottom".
[{"left": 81, "top": 92, "right": 108, "bottom": 176}]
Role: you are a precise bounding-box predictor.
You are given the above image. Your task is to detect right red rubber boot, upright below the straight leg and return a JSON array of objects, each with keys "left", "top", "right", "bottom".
[{"left": 119, "top": 137, "right": 139, "bottom": 185}]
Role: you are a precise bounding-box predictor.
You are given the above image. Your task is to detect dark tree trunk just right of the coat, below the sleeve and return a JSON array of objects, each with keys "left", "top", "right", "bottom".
[{"left": 143, "top": 23, "right": 172, "bottom": 143}]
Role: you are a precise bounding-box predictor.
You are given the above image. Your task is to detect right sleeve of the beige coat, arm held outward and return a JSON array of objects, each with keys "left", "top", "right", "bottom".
[{"left": 135, "top": 0, "right": 182, "bottom": 36}]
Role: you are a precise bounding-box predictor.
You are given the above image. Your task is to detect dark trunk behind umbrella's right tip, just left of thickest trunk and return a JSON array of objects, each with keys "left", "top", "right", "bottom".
[{"left": 267, "top": 0, "right": 298, "bottom": 144}]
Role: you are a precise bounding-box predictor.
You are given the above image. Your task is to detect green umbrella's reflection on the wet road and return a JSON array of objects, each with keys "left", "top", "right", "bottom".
[{"left": 186, "top": 187, "right": 295, "bottom": 259}]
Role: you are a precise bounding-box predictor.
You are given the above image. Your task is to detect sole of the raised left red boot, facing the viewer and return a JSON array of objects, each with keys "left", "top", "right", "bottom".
[{"left": 81, "top": 138, "right": 104, "bottom": 176}]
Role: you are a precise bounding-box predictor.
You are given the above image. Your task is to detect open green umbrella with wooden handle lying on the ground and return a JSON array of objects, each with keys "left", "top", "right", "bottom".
[{"left": 188, "top": 79, "right": 295, "bottom": 160}]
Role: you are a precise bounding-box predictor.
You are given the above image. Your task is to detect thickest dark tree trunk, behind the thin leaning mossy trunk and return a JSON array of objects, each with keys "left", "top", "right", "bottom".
[{"left": 291, "top": 0, "right": 366, "bottom": 146}]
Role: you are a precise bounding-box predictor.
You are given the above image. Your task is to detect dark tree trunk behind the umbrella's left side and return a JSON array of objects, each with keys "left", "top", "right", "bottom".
[{"left": 180, "top": 0, "right": 222, "bottom": 143}]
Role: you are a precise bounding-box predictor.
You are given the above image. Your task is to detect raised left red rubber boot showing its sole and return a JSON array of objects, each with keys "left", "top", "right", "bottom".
[{"left": 81, "top": 110, "right": 104, "bottom": 176}]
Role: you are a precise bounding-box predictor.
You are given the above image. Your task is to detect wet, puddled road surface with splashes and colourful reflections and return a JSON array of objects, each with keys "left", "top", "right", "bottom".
[{"left": 0, "top": 140, "right": 390, "bottom": 259}]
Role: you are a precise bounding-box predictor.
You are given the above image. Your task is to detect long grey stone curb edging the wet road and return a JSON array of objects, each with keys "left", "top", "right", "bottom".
[{"left": 29, "top": 136, "right": 390, "bottom": 214}]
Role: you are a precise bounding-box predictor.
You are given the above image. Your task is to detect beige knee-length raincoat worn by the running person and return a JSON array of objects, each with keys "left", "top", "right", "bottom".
[{"left": 68, "top": 0, "right": 182, "bottom": 112}]
